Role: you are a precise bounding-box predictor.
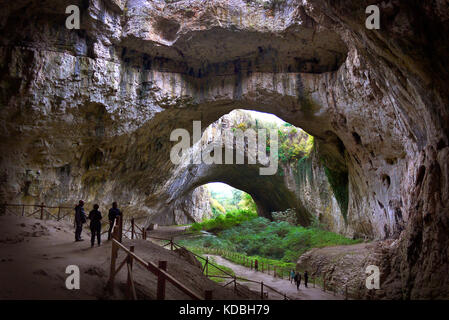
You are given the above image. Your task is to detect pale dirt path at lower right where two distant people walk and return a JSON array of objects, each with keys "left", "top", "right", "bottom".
[{"left": 208, "top": 255, "right": 344, "bottom": 300}]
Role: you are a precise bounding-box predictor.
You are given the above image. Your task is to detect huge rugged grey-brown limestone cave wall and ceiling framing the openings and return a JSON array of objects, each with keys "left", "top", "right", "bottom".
[{"left": 0, "top": 0, "right": 449, "bottom": 298}]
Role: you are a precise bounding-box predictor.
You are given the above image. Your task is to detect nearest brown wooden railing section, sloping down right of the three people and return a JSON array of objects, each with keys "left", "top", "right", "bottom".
[{"left": 107, "top": 217, "right": 212, "bottom": 300}]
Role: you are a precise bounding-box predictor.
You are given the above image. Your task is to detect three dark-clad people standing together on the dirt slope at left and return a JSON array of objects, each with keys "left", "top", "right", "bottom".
[{"left": 75, "top": 200, "right": 122, "bottom": 247}]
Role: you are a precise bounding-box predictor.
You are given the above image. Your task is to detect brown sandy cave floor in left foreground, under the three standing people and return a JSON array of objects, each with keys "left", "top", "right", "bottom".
[{"left": 0, "top": 215, "right": 257, "bottom": 300}]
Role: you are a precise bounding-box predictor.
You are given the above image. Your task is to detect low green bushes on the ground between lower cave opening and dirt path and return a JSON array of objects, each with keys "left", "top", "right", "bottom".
[{"left": 183, "top": 213, "right": 360, "bottom": 263}]
